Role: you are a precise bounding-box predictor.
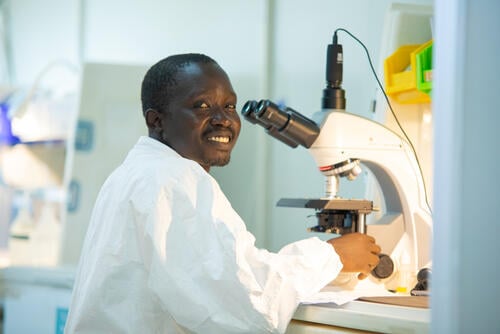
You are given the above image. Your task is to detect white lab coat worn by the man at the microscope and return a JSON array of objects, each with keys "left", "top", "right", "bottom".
[{"left": 65, "top": 137, "right": 342, "bottom": 334}]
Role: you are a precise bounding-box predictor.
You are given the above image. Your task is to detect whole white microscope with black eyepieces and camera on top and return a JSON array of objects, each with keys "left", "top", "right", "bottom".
[{"left": 242, "top": 32, "right": 432, "bottom": 292}]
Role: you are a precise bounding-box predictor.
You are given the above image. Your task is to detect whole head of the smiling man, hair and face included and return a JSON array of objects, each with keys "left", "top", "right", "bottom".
[{"left": 142, "top": 55, "right": 241, "bottom": 172}]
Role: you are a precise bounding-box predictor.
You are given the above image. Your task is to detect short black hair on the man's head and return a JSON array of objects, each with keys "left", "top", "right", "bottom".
[{"left": 141, "top": 53, "right": 218, "bottom": 114}]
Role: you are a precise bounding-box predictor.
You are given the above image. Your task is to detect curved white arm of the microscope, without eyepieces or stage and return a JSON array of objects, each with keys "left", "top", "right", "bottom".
[{"left": 309, "top": 110, "right": 432, "bottom": 270}]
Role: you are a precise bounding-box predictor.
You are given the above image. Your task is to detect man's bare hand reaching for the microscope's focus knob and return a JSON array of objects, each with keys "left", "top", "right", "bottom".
[{"left": 327, "top": 233, "right": 380, "bottom": 279}]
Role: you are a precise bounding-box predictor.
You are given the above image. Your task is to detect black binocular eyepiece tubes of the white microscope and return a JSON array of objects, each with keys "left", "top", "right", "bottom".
[{"left": 241, "top": 100, "right": 320, "bottom": 148}]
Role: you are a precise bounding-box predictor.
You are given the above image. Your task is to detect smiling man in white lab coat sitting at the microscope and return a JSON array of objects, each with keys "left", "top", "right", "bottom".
[{"left": 66, "top": 54, "right": 380, "bottom": 334}]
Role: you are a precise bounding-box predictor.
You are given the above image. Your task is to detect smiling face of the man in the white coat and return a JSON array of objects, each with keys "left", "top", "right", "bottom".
[{"left": 160, "top": 63, "right": 241, "bottom": 171}]
